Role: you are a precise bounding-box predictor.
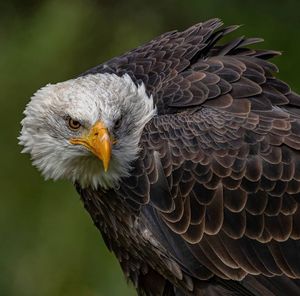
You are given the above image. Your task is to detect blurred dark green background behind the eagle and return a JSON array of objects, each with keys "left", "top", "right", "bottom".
[{"left": 0, "top": 0, "right": 300, "bottom": 296}]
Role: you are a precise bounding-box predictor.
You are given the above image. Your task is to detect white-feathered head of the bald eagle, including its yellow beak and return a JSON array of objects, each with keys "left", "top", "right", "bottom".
[{"left": 19, "top": 74, "right": 155, "bottom": 188}]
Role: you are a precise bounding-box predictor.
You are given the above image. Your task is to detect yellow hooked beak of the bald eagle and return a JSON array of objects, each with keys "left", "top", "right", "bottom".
[{"left": 70, "top": 121, "right": 112, "bottom": 172}]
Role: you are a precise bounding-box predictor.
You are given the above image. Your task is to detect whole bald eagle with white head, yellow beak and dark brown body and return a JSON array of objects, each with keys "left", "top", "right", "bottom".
[{"left": 19, "top": 19, "right": 300, "bottom": 296}]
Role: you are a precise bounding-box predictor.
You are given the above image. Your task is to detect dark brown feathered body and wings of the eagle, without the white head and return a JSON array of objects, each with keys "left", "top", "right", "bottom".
[{"left": 77, "top": 19, "right": 300, "bottom": 295}]
